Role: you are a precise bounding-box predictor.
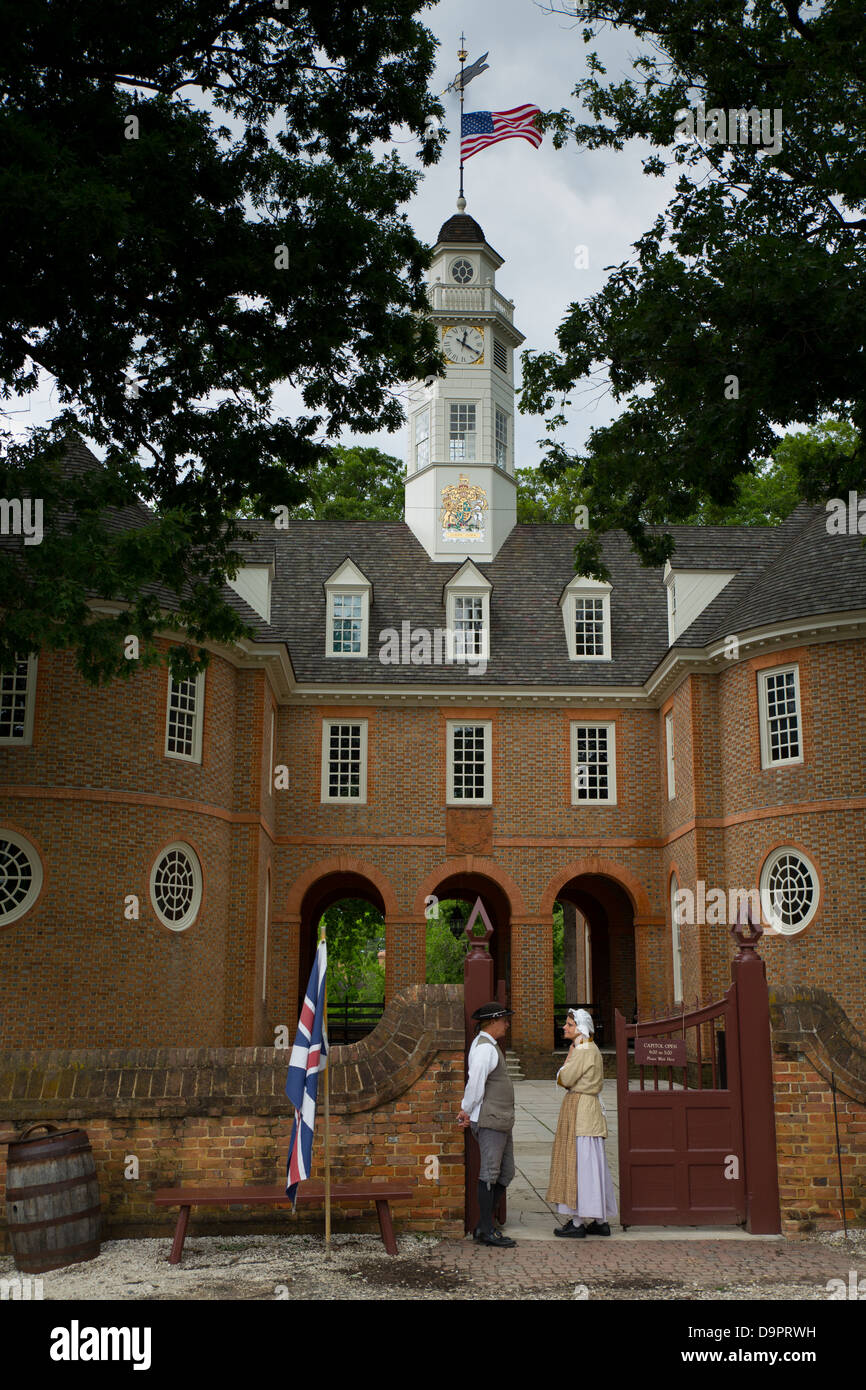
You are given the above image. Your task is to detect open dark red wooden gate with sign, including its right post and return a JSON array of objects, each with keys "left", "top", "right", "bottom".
[{"left": 616, "top": 923, "right": 781, "bottom": 1234}]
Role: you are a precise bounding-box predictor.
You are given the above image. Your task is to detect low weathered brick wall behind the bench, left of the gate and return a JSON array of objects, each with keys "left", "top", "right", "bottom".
[{"left": 0, "top": 986, "right": 464, "bottom": 1250}]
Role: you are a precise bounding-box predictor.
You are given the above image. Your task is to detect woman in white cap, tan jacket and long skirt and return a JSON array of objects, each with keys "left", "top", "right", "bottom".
[{"left": 548, "top": 1009, "right": 616, "bottom": 1236}]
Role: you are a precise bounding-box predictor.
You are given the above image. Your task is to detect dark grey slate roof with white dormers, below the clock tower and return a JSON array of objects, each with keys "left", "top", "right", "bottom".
[{"left": 6, "top": 443, "right": 866, "bottom": 691}]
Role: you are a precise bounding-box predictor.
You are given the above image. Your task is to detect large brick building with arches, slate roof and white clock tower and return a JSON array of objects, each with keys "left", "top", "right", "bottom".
[{"left": 0, "top": 210, "right": 866, "bottom": 1055}]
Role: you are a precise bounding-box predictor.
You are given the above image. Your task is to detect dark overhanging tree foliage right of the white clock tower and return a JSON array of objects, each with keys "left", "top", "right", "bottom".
[{"left": 521, "top": 0, "right": 866, "bottom": 577}]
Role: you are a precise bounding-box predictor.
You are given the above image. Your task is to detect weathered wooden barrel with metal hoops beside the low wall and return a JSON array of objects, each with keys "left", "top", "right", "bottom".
[{"left": 6, "top": 1125, "right": 101, "bottom": 1275}]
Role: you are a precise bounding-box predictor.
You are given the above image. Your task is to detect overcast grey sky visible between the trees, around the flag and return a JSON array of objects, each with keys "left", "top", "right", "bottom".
[{"left": 10, "top": 0, "right": 673, "bottom": 467}]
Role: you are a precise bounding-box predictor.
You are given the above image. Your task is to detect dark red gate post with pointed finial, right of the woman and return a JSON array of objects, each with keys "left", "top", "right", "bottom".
[{"left": 731, "top": 908, "right": 781, "bottom": 1236}]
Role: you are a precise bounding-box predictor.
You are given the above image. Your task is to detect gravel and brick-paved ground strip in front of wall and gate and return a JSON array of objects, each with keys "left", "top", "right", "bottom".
[{"left": 6, "top": 1229, "right": 866, "bottom": 1302}]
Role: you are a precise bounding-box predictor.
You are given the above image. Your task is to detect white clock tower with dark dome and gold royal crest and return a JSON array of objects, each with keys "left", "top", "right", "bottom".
[{"left": 406, "top": 197, "right": 524, "bottom": 562}]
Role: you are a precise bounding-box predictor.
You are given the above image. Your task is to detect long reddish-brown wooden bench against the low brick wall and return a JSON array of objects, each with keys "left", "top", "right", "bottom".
[{"left": 153, "top": 1183, "right": 414, "bottom": 1265}]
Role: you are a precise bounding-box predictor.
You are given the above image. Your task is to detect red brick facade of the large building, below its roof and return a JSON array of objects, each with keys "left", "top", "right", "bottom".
[{"left": 0, "top": 641, "right": 866, "bottom": 1049}]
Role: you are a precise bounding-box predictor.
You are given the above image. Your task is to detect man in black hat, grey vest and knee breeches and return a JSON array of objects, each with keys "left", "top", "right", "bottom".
[{"left": 457, "top": 999, "right": 517, "bottom": 1250}]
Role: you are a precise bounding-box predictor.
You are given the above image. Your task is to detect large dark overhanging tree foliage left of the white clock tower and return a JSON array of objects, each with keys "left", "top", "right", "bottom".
[{"left": 0, "top": 0, "right": 443, "bottom": 680}]
